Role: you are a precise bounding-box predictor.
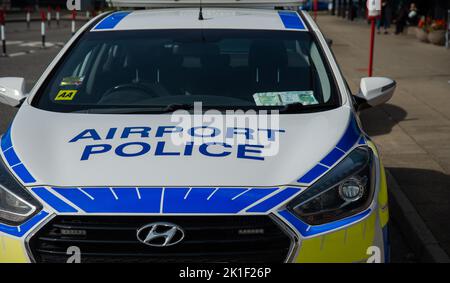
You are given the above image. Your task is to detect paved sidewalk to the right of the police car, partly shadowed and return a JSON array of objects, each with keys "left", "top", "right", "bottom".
[{"left": 318, "top": 16, "right": 450, "bottom": 260}]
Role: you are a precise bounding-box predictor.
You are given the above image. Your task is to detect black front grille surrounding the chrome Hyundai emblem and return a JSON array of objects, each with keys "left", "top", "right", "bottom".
[{"left": 29, "top": 216, "right": 291, "bottom": 263}]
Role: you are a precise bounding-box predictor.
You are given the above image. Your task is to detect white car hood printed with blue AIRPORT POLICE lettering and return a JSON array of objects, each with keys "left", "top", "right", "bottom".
[{"left": 3, "top": 105, "right": 353, "bottom": 187}]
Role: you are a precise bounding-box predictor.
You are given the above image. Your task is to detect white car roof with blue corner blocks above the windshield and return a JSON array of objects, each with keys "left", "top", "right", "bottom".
[{"left": 91, "top": 7, "right": 307, "bottom": 32}]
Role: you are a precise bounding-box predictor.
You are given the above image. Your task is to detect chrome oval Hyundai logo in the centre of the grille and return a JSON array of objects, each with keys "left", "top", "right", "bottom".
[{"left": 136, "top": 222, "right": 184, "bottom": 247}]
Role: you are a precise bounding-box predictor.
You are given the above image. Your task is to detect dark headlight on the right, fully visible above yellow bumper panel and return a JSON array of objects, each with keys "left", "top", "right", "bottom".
[{"left": 287, "top": 147, "right": 375, "bottom": 225}]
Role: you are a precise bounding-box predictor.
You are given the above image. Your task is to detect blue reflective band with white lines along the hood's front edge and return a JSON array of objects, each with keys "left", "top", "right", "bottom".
[{"left": 32, "top": 187, "right": 301, "bottom": 214}]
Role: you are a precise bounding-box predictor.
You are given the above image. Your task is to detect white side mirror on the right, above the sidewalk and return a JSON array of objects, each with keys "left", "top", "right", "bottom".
[{"left": 355, "top": 77, "right": 397, "bottom": 110}]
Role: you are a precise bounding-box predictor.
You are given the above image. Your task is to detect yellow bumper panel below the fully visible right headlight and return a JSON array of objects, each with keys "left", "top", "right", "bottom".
[{"left": 296, "top": 213, "right": 377, "bottom": 263}]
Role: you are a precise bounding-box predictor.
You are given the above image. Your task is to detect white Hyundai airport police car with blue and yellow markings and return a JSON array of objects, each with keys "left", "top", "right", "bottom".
[{"left": 0, "top": 0, "right": 395, "bottom": 262}]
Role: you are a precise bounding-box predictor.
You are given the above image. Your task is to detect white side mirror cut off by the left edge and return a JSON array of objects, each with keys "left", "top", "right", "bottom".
[{"left": 0, "top": 77, "right": 27, "bottom": 107}]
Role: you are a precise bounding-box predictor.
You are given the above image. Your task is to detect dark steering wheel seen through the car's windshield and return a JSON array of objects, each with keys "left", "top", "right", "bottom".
[{"left": 99, "top": 83, "right": 159, "bottom": 103}]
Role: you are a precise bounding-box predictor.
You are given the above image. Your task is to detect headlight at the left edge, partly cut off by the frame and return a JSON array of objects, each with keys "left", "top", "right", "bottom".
[{"left": 0, "top": 155, "right": 42, "bottom": 226}]
